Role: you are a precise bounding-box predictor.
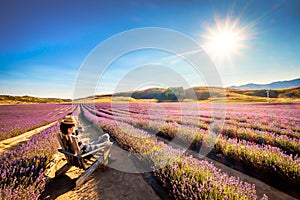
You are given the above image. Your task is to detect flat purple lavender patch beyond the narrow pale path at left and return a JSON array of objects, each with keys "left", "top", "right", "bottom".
[{"left": 0, "top": 104, "right": 72, "bottom": 141}]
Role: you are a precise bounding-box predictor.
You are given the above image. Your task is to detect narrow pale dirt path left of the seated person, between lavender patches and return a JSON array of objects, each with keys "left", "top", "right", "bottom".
[{"left": 0, "top": 121, "right": 57, "bottom": 154}]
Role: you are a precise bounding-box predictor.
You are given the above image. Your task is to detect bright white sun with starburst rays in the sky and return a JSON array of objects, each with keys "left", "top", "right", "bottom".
[{"left": 202, "top": 17, "right": 249, "bottom": 60}]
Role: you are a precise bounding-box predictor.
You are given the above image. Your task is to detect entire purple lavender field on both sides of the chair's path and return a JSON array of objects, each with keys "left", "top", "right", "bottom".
[{"left": 0, "top": 103, "right": 300, "bottom": 199}]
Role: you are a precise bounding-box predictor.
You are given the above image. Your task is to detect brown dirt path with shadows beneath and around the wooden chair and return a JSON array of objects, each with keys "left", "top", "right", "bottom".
[{"left": 41, "top": 113, "right": 165, "bottom": 200}]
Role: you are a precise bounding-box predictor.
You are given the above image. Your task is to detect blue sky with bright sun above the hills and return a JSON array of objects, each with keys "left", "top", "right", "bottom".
[{"left": 0, "top": 0, "right": 300, "bottom": 98}]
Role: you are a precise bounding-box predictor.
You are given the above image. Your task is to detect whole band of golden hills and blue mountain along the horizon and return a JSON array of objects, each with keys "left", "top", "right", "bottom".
[{"left": 0, "top": 78, "right": 300, "bottom": 104}]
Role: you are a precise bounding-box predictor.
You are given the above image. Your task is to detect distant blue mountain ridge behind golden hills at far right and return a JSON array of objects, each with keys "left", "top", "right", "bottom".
[{"left": 229, "top": 78, "right": 300, "bottom": 90}]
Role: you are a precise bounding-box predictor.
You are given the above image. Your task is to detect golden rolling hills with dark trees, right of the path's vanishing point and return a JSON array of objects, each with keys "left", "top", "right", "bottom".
[{"left": 78, "top": 86, "right": 300, "bottom": 103}]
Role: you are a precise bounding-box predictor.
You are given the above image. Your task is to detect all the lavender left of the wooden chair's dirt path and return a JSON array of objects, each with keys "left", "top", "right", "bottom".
[{"left": 0, "top": 104, "right": 79, "bottom": 199}]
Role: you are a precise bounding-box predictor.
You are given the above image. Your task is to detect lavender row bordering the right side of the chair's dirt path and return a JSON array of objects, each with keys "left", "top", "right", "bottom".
[{"left": 83, "top": 105, "right": 267, "bottom": 199}]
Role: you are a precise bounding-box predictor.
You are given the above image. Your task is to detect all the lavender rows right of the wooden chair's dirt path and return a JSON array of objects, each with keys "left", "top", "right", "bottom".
[{"left": 84, "top": 104, "right": 300, "bottom": 199}]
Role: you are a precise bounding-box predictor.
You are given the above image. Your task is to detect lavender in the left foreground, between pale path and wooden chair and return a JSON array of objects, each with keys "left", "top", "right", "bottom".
[{"left": 0, "top": 105, "right": 78, "bottom": 200}]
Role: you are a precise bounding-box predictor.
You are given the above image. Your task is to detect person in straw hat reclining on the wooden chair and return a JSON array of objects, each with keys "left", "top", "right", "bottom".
[{"left": 60, "top": 115, "right": 110, "bottom": 153}]
